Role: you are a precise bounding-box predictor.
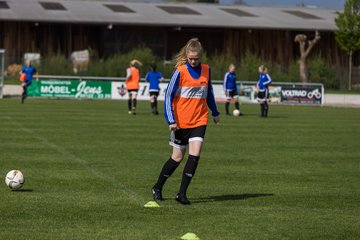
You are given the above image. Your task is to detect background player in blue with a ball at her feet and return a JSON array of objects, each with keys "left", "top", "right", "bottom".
[{"left": 224, "top": 64, "right": 242, "bottom": 115}]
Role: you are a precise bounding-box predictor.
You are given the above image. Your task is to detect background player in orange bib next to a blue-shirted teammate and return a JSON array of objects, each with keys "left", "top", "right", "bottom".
[{"left": 125, "top": 59, "right": 142, "bottom": 115}]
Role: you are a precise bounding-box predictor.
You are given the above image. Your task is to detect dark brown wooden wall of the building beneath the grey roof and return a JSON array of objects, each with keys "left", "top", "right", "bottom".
[{"left": 0, "top": 22, "right": 354, "bottom": 66}]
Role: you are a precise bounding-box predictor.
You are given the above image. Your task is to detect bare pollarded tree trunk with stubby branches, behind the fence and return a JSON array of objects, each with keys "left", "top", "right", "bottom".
[{"left": 294, "top": 31, "right": 320, "bottom": 83}]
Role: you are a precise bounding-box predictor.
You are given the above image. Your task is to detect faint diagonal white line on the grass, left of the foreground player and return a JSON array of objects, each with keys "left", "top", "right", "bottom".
[{"left": 3, "top": 116, "right": 146, "bottom": 205}]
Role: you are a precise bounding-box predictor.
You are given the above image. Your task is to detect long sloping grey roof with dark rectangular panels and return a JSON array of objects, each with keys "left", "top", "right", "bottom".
[{"left": 0, "top": 0, "right": 337, "bottom": 31}]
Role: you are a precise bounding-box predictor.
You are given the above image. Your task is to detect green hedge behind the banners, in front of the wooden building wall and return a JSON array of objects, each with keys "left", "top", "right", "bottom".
[{"left": 5, "top": 47, "right": 340, "bottom": 89}]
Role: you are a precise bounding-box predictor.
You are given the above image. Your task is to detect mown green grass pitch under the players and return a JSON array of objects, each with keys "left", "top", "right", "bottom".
[{"left": 0, "top": 99, "right": 360, "bottom": 240}]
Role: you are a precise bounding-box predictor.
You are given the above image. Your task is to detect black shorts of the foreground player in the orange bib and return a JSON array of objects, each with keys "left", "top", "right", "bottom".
[{"left": 169, "top": 125, "right": 206, "bottom": 149}]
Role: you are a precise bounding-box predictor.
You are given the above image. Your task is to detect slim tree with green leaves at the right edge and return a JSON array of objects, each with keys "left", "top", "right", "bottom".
[{"left": 334, "top": 0, "right": 360, "bottom": 91}]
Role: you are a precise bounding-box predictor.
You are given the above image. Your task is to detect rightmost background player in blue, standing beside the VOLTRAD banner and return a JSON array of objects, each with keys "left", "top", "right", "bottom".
[{"left": 256, "top": 65, "right": 272, "bottom": 117}]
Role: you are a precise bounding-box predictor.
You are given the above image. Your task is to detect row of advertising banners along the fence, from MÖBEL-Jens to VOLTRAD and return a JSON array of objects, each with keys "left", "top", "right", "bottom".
[{"left": 4, "top": 75, "right": 324, "bottom": 105}]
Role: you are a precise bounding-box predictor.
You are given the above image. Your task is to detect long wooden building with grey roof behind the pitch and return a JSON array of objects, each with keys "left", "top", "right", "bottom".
[{"left": 0, "top": 0, "right": 360, "bottom": 79}]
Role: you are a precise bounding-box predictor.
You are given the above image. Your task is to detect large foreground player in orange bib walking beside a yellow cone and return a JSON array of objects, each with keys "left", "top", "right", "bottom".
[{"left": 151, "top": 38, "right": 220, "bottom": 205}]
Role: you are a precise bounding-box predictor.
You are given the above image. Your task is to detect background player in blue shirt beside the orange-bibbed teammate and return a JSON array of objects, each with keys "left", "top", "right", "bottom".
[{"left": 145, "top": 65, "right": 164, "bottom": 115}]
